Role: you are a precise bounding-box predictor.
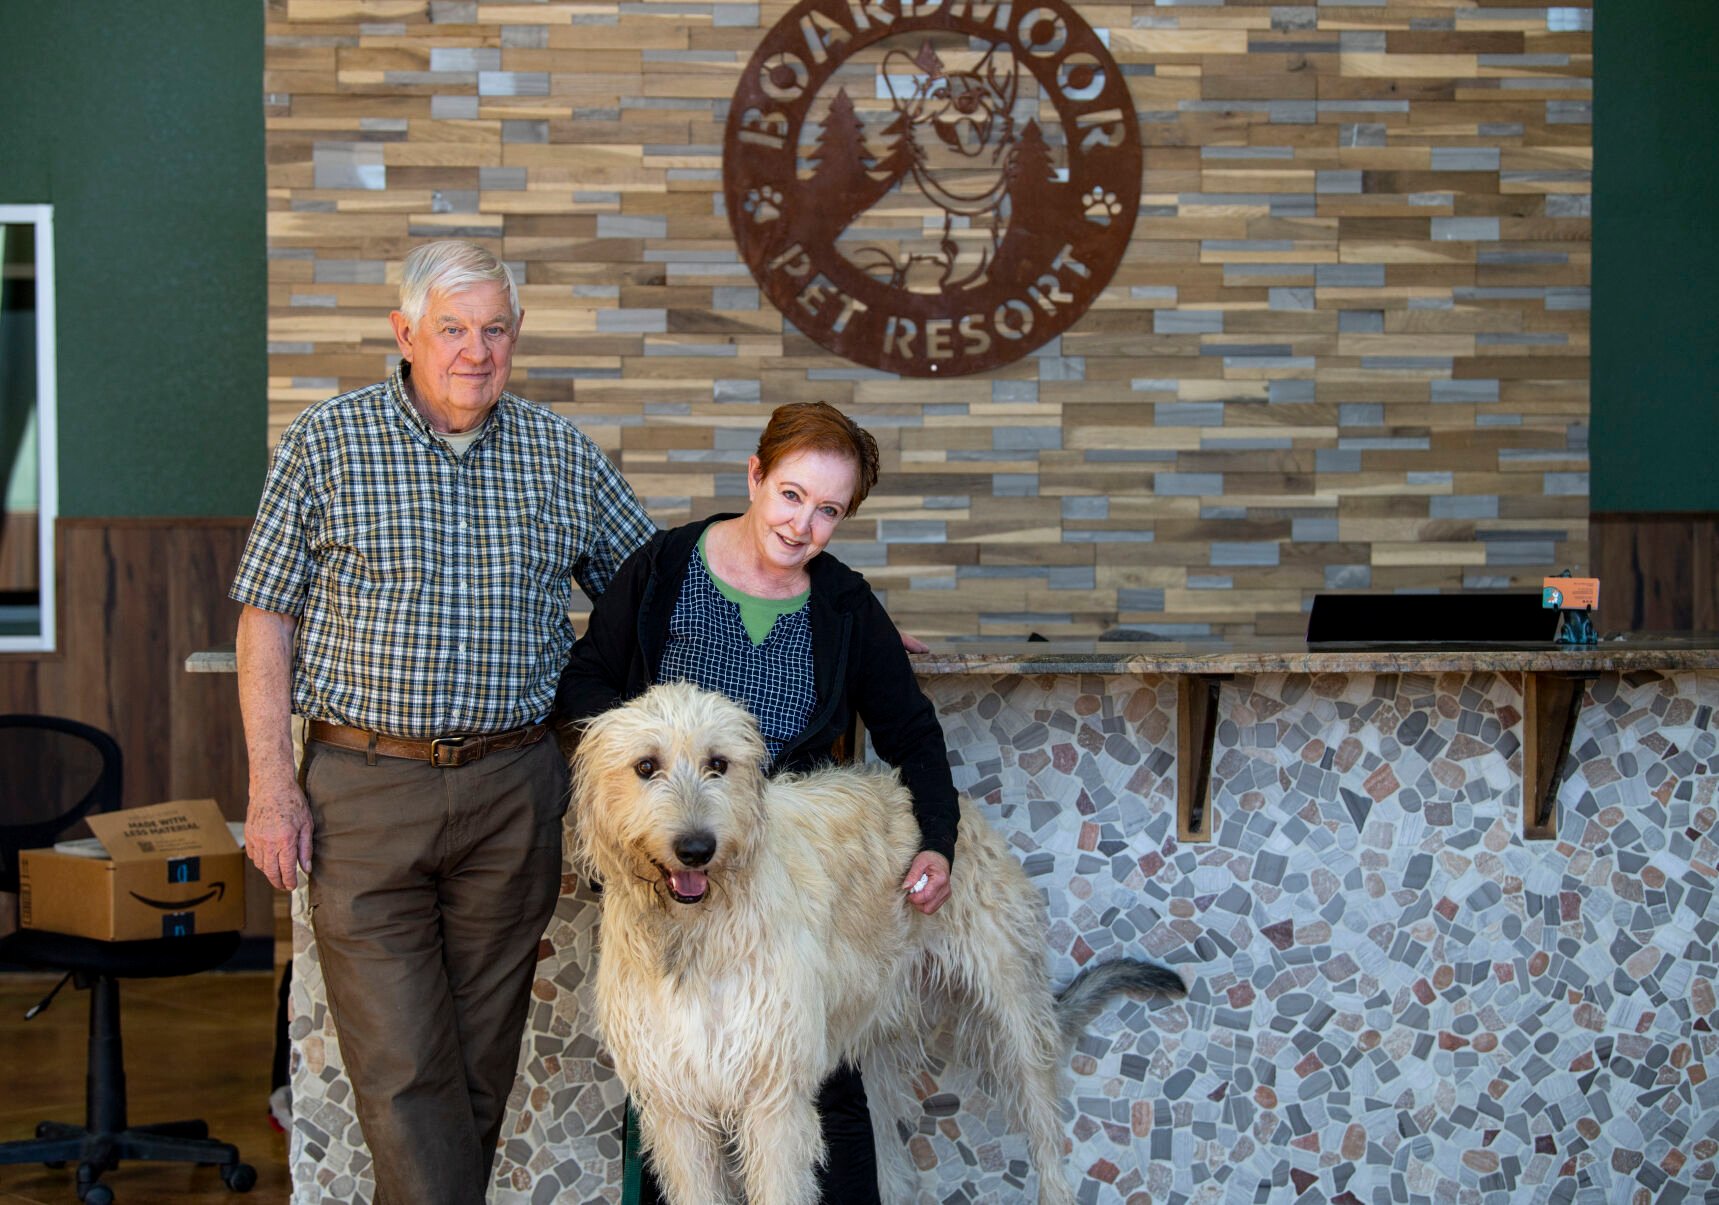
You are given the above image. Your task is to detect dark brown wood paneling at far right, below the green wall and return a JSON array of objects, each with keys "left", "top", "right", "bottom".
[{"left": 1588, "top": 514, "right": 1719, "bottom": 633}]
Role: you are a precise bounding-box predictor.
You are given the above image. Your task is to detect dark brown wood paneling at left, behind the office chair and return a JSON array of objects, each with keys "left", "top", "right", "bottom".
[{"left": 0, "top": 519, "right": 273, "bottom": 935}]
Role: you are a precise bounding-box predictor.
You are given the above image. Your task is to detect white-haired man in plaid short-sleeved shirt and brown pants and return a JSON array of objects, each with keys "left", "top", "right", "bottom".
[{"left": 232, "top": 242, "right": 652, "bottom": 1205}]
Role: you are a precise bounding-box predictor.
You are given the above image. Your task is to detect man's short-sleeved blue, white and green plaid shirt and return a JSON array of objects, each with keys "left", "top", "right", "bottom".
[{"left": 230, "top": 366, "right": 655, "bottom": 737}]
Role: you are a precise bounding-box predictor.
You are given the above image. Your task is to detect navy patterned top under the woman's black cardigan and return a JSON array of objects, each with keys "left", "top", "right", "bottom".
[{"left": 657, "top": 554, "right": 818, "bottom": 763}]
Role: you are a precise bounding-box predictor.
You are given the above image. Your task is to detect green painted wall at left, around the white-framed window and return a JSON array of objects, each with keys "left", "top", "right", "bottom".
[{"left": 0, "top": 0, "right": 268, "bottom": 516}]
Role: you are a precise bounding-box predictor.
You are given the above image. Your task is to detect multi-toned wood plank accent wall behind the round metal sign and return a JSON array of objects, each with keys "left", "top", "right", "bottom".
[{"left": 265, "top": 0, "right": 1594, "bottom": 636}]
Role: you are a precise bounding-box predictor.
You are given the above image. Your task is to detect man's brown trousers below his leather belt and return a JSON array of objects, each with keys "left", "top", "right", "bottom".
[{"left": 304, "top": 741, "right": 567, "bottom": 1205}]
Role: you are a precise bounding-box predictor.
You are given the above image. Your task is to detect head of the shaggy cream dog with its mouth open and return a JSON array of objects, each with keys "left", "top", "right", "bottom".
[{"left": 572, "top": 682, "right": 767, "bottom": 904}]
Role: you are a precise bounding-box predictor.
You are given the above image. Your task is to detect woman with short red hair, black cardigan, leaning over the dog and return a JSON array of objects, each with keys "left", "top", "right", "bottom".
[{"left": 557, "top": 402, "right": 957, "bottom": 1205}]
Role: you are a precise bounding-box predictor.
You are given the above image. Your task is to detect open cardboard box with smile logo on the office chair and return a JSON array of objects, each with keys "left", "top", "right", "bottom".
[{"left": 19, "top": 799, "right": 244, "bottom": 942}]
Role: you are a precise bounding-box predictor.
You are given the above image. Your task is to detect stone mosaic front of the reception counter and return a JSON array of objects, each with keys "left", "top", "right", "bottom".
[{"left": 292, "top": 667, "right": 1719, "bottom": 1205}]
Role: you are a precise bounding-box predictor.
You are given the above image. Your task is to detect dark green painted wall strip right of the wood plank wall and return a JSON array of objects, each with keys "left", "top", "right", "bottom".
[{"left": 1590, "top": 0, "right": 1719, "bottom": 512}]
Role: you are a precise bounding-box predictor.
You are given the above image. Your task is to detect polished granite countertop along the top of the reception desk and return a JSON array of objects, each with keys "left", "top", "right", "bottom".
[{"left": 186, "top": 633, "right": 1719, "bottom": 674}]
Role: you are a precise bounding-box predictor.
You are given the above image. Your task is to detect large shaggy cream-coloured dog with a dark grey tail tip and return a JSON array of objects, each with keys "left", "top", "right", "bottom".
[{"left": 572, "top": 684, "right": 1183, "bottom": 1205}]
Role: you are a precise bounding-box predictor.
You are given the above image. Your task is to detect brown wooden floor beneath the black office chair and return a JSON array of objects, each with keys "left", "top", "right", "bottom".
[{"left": 0, "top": 971, "right": 291, "bottom": 1205}]
